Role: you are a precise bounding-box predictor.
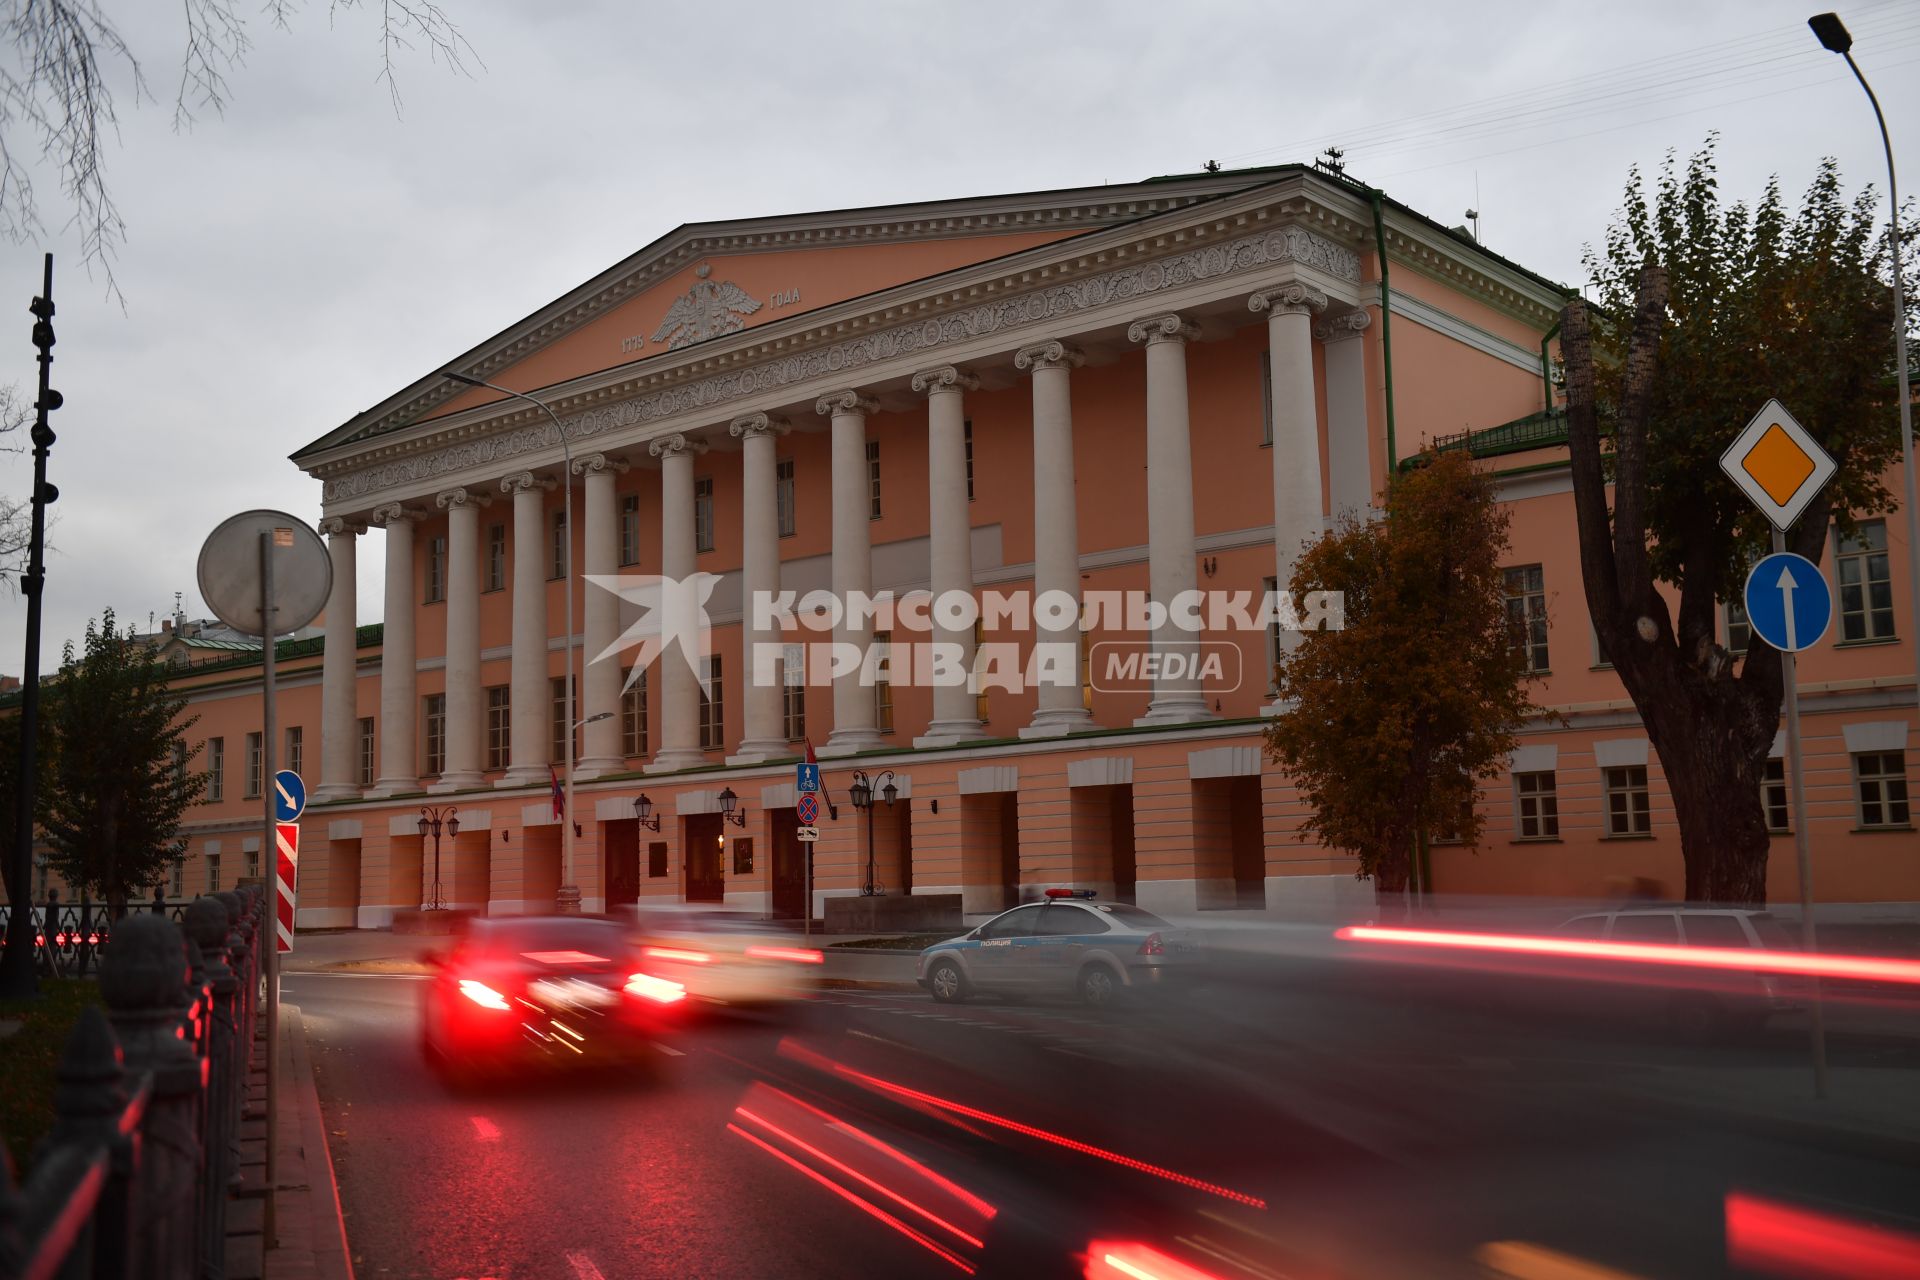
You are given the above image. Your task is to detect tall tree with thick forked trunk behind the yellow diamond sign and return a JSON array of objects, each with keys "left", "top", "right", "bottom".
[{"left": 1561, "top": 138, "right": 1912, "bottom": 902}]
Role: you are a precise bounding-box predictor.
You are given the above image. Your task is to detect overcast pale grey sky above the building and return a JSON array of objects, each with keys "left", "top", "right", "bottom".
[{"left": 0, "top": 0, "right": 1920, "bottom": 672}]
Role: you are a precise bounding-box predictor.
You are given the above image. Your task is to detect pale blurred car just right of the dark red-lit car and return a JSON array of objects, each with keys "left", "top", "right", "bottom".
[{"left": 634, "top": 904, "right": 824, "bottom": 1006}]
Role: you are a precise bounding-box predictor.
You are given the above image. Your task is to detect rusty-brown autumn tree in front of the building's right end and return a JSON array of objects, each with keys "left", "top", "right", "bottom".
[{"left": 1265, "top": 453, "right": 1536, "bottom": 894}]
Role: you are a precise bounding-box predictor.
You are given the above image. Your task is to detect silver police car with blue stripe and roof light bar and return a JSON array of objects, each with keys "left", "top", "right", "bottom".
[{"left": 916, "top": 889, "right": 1206, "bottom": 1007}]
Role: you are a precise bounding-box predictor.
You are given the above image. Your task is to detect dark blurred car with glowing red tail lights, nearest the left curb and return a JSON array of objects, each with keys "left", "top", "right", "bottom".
[{"left": 420, "top": 915, "right": 685, "bottom": 1077}]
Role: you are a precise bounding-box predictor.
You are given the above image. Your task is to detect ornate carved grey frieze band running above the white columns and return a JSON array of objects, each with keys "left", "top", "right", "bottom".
[{"left": 324, "top": 226, "right": 1359, "bottom": 503}]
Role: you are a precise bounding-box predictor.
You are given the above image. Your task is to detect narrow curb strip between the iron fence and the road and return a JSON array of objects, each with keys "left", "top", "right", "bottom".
[{"left": 263, "top": 1004, "right": 353, "bottom": 1280}]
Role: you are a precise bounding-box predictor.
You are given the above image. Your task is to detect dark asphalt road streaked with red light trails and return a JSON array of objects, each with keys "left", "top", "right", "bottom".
[{"left": 286, "top": 958, "right": 1920, "bottom": 1280}]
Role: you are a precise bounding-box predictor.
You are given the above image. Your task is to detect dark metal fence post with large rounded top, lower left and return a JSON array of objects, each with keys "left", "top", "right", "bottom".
[{"left": 100, "top": 915, "right": 202, "bottom": 1280}]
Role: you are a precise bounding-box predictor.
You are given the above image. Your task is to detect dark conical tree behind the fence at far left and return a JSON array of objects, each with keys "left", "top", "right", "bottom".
[{"left": 36, "top": 610, "right": 207, "bottom": 906}]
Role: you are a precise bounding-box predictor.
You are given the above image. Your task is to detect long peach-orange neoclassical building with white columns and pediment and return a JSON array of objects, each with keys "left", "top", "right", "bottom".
[{"left": 153, "top": 167, "right": 1920, "bottom": 925}]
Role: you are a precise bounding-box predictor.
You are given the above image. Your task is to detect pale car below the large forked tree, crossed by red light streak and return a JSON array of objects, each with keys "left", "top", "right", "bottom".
[{"left": 1559, "top": 906, "right": 1805, "bottom": 1040}]
